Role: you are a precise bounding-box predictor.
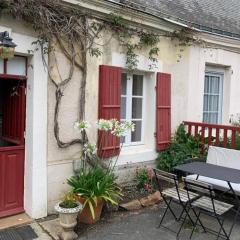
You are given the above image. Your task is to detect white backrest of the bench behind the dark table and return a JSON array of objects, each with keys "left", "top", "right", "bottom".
[{"left": 207, "top": 146, "right": 240, "bottom": 170}]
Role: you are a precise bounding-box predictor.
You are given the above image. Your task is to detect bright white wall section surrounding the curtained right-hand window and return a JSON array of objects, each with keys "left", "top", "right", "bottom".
[{"left": 186, "top": 43, "right": 240, "bottom": 124}]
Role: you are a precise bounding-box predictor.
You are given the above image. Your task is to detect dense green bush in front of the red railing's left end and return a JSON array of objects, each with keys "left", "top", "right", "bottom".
[{"left": 157, "top": 124, "right": 206, "bottom": 172}]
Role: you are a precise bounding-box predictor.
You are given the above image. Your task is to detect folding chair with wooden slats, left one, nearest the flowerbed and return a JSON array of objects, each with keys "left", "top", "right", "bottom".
[{"left": 153, "top": 169, "right": 201, "bottom": 237}]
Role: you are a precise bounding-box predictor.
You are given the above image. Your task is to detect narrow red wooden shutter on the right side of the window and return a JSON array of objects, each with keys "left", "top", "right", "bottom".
[{"left": 156, "top": 73, "right": 171, "bottom": 151}]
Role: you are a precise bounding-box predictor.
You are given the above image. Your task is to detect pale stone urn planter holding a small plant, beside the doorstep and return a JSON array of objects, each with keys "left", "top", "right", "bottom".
[{"left": 55, "top": 192, "right": 82, "bottom": 240}]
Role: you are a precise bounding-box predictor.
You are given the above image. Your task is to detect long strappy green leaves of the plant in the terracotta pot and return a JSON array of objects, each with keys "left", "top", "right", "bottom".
[{"left": 67, "top": 166, "right": 122, "bottom": 219}]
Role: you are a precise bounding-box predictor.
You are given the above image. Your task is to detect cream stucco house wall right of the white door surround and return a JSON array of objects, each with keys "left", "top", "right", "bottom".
[{"left": 48, "top": 30, "right": 240, "bottom": 212}]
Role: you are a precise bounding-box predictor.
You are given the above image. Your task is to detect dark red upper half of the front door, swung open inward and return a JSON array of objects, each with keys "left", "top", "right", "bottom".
[{"left": 2, "top": 83, "right": 26, "bottom": 145}]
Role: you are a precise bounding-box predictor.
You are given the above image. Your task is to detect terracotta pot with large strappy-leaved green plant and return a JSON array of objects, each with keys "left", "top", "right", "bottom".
[{"left": 68, "top": 166, "right": 122, "bottom": 224}]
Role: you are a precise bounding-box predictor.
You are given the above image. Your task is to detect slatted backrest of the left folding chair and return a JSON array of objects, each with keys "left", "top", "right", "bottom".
[{"left": 153, "top": 169, "right": 178, "bottom": 192}]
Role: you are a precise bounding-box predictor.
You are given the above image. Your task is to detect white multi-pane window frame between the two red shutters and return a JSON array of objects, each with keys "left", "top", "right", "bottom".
[{"left": 121, "top": 72, "right": 146, "bottom": 147}]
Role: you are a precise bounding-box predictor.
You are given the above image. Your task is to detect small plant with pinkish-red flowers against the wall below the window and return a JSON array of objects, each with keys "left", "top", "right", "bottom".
[{"left": 136, "top": 167, "right": 154, "bottom": 192}]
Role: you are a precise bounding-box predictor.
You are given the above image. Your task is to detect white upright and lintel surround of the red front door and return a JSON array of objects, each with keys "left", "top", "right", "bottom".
[{"left": 0, "top": 16, "right": 48, "bottom": 218}]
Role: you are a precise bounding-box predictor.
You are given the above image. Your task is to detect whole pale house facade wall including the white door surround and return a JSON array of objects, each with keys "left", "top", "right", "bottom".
[{"left": 0, "top": 8, "right": 240, "bottom": 218}]
